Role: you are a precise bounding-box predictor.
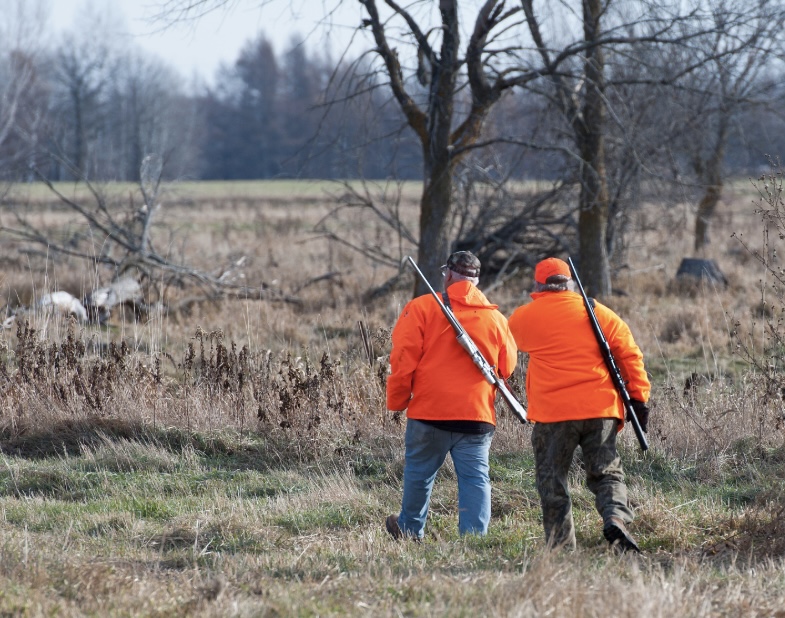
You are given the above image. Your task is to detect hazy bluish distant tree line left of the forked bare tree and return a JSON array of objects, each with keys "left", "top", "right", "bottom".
[{"left": 0, "top": 31, "right": 428, "bottom": 181}]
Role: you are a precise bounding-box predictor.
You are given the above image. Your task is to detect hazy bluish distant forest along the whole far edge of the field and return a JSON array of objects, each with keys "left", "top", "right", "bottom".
[{"left": 0, "top": 24, "right": 785, "bottom": 181}]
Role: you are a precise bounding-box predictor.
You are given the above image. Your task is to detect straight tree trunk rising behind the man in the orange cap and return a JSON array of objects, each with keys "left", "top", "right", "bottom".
[{"left": 577, "top": 0, "right": 611, "bottom": 296}]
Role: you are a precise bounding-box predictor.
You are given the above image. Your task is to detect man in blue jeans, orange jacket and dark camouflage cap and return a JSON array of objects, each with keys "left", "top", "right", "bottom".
[{"left": 385, "top": 251, "right": 517, "bottom": 540}]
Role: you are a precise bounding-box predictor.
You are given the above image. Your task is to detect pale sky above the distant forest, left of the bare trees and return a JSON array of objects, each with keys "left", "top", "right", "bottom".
[{"left": 50, "top": 0, "right": 360, "bottom": 82}]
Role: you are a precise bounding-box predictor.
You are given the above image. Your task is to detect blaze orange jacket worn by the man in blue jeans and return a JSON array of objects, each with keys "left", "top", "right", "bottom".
[{"left": 387, "top": 281, "right": 518, "bottom": 425}]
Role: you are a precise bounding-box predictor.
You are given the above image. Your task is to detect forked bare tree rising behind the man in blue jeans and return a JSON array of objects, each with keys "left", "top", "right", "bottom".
[{"left": 150, "top": 0, "right": 580, "bottom": 294}]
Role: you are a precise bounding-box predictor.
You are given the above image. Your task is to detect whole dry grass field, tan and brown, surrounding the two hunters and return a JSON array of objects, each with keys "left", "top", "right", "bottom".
[{"left": 0, "top": 176, "right": 785, "bottom": 617}]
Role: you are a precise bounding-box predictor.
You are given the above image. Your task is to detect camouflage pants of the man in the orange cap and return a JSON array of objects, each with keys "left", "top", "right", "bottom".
[{"left": 532, "top": 418, "right": 633, "bottom": 549}]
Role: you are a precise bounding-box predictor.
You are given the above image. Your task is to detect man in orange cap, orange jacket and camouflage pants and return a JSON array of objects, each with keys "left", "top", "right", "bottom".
[{"left": 509, "top": 258, "right": 651, "bottom": 552}]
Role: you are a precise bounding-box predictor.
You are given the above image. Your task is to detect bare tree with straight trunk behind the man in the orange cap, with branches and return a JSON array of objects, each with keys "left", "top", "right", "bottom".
[{"left": 521, "top": 0, "right": 780, "bottom": 295}]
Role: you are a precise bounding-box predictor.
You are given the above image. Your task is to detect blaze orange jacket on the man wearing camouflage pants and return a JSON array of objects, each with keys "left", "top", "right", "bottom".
[{"left": 509, "top": 291, "right": 651, "bottom": 430}]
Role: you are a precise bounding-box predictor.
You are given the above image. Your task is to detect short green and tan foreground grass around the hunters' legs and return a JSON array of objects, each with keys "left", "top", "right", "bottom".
[{"left": 0, "top": 422, "right": 785, "bottom": 616}]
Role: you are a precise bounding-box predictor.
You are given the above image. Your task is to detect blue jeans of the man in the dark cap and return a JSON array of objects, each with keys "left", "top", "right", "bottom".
[{"left": 398, "top": 419, "right": 493, "bottom": 538}]
